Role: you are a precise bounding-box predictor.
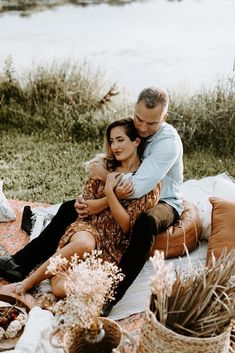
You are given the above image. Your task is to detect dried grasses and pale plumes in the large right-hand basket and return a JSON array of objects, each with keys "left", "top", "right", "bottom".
[{"left": 150, "top": 251, "right": 235, "bottom": 337}]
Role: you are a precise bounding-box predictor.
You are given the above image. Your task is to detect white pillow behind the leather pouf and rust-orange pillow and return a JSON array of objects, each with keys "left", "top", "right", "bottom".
[{"left": 182, "top": 173, "right": 235, "bottom": 240}]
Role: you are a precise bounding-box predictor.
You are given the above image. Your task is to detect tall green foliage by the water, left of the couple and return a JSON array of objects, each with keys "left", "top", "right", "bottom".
[{"left": 0, "top": 60, "right": 116, "bottom": 141}]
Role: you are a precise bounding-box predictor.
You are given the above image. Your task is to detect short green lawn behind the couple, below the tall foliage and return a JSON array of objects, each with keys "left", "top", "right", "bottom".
[{"left": 0, "top": 131, "right": 235, "bottom": 203}]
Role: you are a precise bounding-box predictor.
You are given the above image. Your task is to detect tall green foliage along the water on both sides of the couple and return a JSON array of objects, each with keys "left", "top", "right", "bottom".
[{"left": 0, "top": 59, "right": 235, "bottom": 156}]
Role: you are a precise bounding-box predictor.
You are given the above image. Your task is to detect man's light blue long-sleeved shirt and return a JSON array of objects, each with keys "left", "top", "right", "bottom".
[{"left": 125, "top": 122, "right": 183, "bottom": 215}]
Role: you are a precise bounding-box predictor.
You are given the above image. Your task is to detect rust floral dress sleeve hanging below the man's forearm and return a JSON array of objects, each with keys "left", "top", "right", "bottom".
[{"left": 126, "top": 184, "right": 160, "bottom": 228}]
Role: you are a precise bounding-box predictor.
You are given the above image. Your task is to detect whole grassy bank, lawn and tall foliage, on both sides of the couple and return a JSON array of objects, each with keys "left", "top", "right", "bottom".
[{"left": 0, "top": 60, "right": 235, "bottom": 203}]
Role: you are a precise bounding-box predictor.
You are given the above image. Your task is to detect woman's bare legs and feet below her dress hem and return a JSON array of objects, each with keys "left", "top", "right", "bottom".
[{"left": 1, "top": 231, "right": 96, "bottom": 297}]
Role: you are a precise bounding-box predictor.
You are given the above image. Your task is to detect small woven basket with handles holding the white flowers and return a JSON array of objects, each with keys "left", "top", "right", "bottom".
[{"left": 50, "top": 318, "right": 136, "bottom": 353}]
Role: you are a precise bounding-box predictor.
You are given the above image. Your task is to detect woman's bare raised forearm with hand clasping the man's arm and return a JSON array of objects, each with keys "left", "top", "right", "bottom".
[{"left": 105, "top": 172, "right": 131, "bottom": 233}]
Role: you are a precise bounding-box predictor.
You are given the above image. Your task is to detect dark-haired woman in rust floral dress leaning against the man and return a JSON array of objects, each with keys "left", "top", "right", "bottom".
[{"left": 2, "top": 119, "right": 159, "bottom": 298}]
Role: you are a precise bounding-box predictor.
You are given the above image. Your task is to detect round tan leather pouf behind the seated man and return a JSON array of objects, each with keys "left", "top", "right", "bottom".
[{"left": 150, "top": 200, "right": 202, "bottom": 258}]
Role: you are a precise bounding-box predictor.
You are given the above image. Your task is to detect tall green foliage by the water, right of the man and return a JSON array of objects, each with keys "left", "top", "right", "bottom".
[{"left": 169, "top": 79, "right": 235, "bottom": 155}]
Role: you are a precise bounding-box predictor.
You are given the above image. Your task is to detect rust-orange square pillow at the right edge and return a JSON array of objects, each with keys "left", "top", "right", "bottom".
[{"left": 206, "top": 197, "right": 235, "bottom": 265}]
